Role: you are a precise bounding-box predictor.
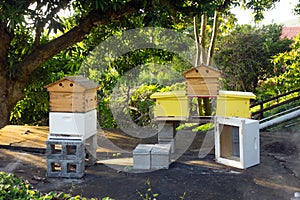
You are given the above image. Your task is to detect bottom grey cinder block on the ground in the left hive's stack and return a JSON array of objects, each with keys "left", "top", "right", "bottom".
[{"left": 46, "top": 159, "right": 85, "bottom": 178}]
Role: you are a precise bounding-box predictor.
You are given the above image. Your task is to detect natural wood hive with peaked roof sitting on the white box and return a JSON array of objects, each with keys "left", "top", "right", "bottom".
[{"left": 45, "top": 76, "right": 99, "bottom": 113}]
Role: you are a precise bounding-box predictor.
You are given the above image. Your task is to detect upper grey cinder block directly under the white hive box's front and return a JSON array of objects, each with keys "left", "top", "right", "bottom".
[{"left": 46, "top": 140, "right": 85, "bottom": 160}]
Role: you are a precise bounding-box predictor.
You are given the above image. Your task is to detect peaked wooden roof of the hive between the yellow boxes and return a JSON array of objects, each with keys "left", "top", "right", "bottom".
[{"left": 183, "top": 64, "right": 221, "bottom": 79}]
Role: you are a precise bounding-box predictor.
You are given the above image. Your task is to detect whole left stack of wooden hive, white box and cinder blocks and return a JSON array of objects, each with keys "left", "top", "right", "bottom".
[{"left": 45, "top": 76, "right": 98, "bottom": 178}]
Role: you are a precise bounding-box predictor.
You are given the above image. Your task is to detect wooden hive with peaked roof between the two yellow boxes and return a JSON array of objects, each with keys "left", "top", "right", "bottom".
[{"left": 183, "top": 64, "right": 221, "bottom": 97}]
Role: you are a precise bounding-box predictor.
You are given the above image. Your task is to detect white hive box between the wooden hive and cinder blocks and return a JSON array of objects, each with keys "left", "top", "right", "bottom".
[{"left": 49, "top": 109, "right": 97, "bottom": 139}]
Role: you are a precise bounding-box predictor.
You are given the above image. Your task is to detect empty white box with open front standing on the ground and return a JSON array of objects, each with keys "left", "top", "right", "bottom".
[{"left": 215, "top": 117, "right": 260, "bottom": 169}]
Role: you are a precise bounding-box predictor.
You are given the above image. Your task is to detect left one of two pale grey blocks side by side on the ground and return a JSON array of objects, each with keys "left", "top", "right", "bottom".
[{"left": 133, "top": 144, "right": 154, "bottom": 169}]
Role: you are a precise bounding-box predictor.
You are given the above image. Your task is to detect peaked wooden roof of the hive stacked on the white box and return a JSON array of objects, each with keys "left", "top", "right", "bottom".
[{"left": 44, "top": 75, "right": 99, "bottom": 92}]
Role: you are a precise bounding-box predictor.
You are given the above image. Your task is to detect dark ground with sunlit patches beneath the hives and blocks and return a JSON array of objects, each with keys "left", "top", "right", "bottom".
[{"left": 0, "top": 127, "right": 300, "bottom": 200}]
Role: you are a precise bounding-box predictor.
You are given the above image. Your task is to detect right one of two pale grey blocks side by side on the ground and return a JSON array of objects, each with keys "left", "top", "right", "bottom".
[{"left": 151, "top": 144, "right": 171, "bottom": 169}]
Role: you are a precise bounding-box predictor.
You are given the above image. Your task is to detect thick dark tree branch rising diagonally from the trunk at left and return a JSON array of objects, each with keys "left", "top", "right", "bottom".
[{"left": 16, "top": 3, "right": 137, "bottom": 80}]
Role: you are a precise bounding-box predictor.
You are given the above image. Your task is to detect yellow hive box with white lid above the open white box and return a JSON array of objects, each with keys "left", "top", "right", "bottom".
[{"left": 216, "top": 90, "right": 256, "bottom": 118}]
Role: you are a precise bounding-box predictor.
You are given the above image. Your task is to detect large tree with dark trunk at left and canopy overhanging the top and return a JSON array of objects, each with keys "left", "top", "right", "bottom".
[{"left": 0, "top": 0, "right": 284, "bottom": 128}]
